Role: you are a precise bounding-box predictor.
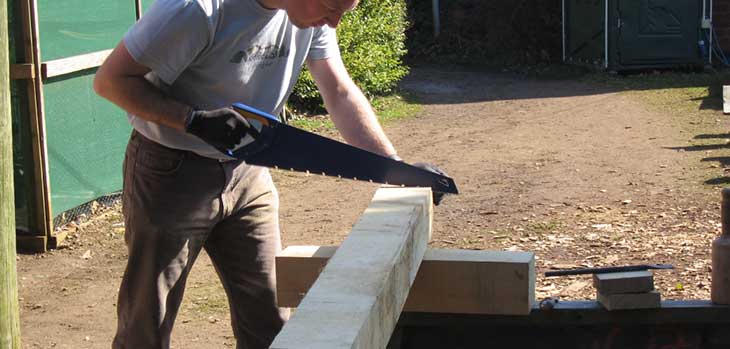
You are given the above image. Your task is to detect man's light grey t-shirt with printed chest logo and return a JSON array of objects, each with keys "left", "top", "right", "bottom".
[{"left": 124, "top": 0, "right": 340, "bottom": 159}]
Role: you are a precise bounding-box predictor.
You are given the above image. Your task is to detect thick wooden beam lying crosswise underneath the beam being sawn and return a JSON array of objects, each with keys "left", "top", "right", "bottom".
[{"left": 276, "top": 246, "right": 535, "bottom": 315}]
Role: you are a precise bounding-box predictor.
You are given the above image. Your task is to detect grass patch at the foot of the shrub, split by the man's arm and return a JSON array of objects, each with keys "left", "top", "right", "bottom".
[{"left": 291, "top": 94, "right": 421, "bottom": 132}]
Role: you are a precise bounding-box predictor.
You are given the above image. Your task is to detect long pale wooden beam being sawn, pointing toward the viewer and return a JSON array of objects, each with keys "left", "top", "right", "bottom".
[{"left": 271, "top": 188, "right": 433, "bottom": 349}]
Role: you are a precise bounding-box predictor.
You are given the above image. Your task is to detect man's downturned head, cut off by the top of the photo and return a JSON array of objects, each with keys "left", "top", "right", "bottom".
[{"left": 276, "top": 0, "right": 358, "bottom": 28}]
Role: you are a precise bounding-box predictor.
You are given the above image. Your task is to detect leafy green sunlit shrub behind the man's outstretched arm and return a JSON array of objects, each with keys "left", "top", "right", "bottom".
[{"left": 289, "top": 0, "right": 408, "bottom": 111}]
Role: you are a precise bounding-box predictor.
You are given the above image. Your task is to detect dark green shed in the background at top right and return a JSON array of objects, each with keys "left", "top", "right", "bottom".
[{"left": 562, "top": 0, "right": 713, "bottom": 71}]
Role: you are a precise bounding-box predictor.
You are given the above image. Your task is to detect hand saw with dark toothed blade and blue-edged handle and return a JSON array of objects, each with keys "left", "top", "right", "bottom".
[{"left": 227, "top": 103, "right": 459, "bottom": 194}]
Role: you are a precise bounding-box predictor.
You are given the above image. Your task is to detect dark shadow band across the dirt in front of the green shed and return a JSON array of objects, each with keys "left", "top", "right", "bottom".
[{"left": 400, "top": 65, "right": 730, "bottom": 110}]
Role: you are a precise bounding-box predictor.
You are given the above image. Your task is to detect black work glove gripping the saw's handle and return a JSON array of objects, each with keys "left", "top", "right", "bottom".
[{"left": 185, "top": 108, "right": 252, "bottom": 154}]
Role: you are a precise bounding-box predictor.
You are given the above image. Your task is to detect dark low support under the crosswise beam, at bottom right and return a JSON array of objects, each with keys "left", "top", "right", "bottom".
[{"left": 388, "top": 301, "right": 730, "bottom": 349}]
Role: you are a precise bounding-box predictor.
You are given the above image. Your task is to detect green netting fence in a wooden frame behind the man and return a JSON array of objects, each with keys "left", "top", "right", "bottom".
[{"left": 9, "top": 0, "right": 152, "bottom": 239}]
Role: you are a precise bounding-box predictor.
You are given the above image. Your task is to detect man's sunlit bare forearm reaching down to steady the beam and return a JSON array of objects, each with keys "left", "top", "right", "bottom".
[{"left": 307, "top": 57, "right": 396, "bottom": 156}]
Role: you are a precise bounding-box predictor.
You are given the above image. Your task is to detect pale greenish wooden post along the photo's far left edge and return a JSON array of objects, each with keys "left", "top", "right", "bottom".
[{"left": 0, "top": 0, "right": 20, "bottom": 349}]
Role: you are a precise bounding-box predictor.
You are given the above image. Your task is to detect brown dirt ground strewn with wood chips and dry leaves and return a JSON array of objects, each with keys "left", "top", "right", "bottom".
[{"left": 12, "top": 68, "right": 730, "bottom": 348}]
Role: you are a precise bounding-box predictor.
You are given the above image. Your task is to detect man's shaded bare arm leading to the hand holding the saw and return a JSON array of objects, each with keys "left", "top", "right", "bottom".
[{"left": 94, "top": 42, "right": 192, "bottom": 131}]
